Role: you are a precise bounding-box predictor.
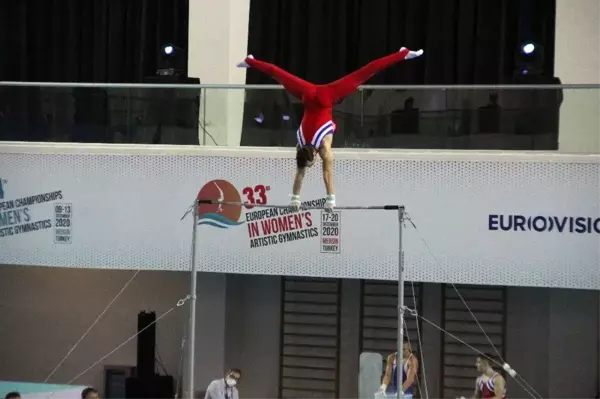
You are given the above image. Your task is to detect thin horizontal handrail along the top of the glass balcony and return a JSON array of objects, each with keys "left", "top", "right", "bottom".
[{"left": 0, "top": 81, "right": 600, "bottom": 90}]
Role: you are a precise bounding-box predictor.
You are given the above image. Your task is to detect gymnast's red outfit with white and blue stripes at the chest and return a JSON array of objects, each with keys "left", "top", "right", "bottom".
[{"left": 245, "top": 48, "right": 410, "bottom": 149}]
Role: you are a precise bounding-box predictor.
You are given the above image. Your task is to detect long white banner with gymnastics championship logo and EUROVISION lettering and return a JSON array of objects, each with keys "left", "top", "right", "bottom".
[{"left": 0, "top": 144, "right": 600, "bottom": 289}]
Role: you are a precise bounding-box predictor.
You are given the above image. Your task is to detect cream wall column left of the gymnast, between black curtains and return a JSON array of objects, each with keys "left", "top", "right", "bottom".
[{"left": 188, "top": 0, "right": 250, "bottom": 146}]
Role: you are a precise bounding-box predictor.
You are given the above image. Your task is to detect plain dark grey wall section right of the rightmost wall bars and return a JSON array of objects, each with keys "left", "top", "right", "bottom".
[{"left": 506, "top": 287, "right": 600, "bottom": 399}]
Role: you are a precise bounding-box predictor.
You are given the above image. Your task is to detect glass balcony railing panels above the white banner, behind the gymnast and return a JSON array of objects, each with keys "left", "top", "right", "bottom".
[{"left": 0, "top": 82, "right": 600, "bottom": 150}]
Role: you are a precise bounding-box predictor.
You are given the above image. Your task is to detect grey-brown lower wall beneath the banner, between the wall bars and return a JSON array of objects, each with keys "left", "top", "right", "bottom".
[{"left": 0, "top": 266, "right": 600, "bottom": 399}]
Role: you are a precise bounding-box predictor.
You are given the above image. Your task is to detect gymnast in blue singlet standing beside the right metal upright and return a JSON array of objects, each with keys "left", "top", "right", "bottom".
[{"left": 380, "top": 342, "right": 419, "bottom": 395}]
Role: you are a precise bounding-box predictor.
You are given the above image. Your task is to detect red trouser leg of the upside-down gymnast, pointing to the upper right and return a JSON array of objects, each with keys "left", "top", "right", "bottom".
[{"left": 327, "top": 48, "right": 410, "bottom": 103}]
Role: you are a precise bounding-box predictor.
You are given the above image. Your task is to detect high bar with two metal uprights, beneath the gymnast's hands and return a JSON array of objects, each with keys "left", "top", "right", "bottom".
[{"left": 185, "top": 202, "right": 406, "bottom": 399}]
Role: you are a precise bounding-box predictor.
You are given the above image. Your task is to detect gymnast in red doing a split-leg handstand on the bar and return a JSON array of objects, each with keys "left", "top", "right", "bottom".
[{"left": 237, "top": 47, "right": 423, "bottom": 212}]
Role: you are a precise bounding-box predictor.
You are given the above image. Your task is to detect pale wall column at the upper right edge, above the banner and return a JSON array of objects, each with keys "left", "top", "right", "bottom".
[{"left": 554, "top": 0, "right": 600, "bottom": 153}]
